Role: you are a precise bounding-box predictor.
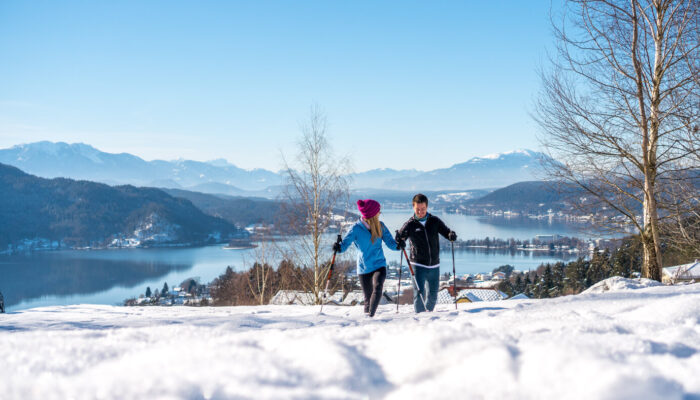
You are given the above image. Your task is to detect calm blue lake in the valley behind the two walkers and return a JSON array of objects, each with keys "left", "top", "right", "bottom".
[{"left": 0, "top": 210, "right": 588, "bottom": 311}]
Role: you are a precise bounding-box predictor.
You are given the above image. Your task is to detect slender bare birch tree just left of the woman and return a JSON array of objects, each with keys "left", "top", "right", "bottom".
[{"left": 281, "top": 106, "right": 350, "bottom": 302}]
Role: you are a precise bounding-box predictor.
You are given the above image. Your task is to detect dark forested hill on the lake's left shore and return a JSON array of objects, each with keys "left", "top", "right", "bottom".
[{"left": 0, "top": 164, "right": 245, "bottom": 251}]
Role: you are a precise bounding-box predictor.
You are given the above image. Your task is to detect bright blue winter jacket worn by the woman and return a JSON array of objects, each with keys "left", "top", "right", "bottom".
[{"left": 340, "top": 221, "right": 398, "bottom": 275}]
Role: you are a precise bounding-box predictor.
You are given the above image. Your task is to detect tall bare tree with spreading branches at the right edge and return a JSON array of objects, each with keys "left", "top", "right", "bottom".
[{"left": 536, "top": 0, "right": 700, "bottom": 281}]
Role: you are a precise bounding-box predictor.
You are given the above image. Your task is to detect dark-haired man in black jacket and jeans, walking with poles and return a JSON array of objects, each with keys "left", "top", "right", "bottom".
[{"left": 396, "top": 193, "right": 457, "bottom": 313}]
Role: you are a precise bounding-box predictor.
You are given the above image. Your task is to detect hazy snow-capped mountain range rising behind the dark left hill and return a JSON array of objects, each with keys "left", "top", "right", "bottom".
[{"left": 0, "top": 141, "right": 281, "bottom": 190}]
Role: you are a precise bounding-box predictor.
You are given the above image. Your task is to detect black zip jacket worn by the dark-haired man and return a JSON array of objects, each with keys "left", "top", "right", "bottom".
[{"left": 399, "top": 214, "right": 450, "bottom": 265}]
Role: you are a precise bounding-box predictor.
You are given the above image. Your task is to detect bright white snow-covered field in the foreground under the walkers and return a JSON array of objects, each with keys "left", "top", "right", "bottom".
[{"left": 0, "top": 284, "right": 700, "bottom": 400}]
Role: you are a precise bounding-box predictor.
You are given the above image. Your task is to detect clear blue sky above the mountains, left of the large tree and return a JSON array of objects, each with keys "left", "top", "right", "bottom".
[{"left": 0, "top": 0, "right": 552, "bottom": 171}]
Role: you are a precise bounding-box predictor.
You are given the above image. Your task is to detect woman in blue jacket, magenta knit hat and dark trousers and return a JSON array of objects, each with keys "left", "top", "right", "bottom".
[{"left": 333, "top": 199, "right": 398, "bottom": 317}]
